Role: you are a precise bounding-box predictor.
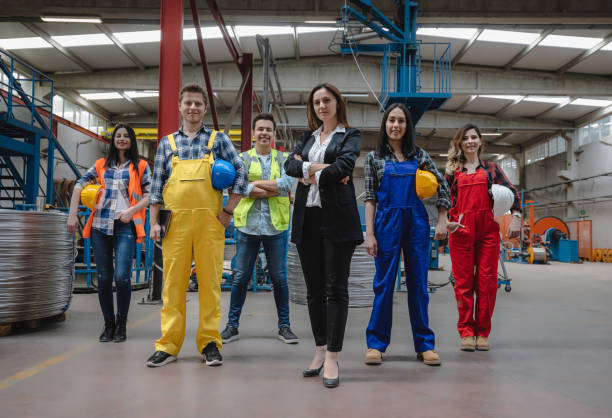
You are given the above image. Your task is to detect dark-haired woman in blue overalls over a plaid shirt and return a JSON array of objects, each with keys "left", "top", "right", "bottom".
[{"left": 365, "top": 103, "right": 450, "bottom": 366}]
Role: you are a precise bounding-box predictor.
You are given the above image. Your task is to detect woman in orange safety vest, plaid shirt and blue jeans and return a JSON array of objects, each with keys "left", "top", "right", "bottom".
[{"left": 67, "top": 124, "right": 151, "bottom": 342}]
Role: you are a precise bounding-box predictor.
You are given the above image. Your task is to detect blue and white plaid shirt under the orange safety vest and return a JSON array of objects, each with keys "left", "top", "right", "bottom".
[{"left": 76, "top": 161, "right": 151, "bottom": 235}]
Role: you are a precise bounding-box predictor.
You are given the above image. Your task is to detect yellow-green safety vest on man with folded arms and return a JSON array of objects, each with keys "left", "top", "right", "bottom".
[{"left": 234, "top": 148, "right": 289, "bottom": 231}]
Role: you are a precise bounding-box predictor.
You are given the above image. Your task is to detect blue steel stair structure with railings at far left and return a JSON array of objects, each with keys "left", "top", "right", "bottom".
[{"left": 0, "top": 50, "right": 81, "bottom": 207}]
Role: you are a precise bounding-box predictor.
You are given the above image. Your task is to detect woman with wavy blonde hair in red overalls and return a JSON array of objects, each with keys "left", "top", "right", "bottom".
[{"left": 445, "top": 124, "right": 521, "bottom": 351}]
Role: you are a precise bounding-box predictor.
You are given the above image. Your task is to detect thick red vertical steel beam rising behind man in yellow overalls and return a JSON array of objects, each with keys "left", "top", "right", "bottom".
[{"left": 157, "top": 0, "right": 183, "bottom": 144}]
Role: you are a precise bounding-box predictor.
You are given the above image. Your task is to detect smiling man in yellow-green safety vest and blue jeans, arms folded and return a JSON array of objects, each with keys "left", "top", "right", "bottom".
[{"left": 221, "top": 113, "right": 299, "bottom": 344}]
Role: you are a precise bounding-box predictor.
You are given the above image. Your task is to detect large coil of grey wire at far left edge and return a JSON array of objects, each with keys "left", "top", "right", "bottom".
[{"left": 0, "top": 209, "right": 75, "bottom": 324}]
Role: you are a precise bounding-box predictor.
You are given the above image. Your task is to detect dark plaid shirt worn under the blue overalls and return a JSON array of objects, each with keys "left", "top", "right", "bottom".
[{"left": 364, "top": 145, "right": 450, "bottom": 208}]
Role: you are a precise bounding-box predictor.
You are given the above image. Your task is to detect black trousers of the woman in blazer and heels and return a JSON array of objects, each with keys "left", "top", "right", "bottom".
[{"left": 297, "top": 207, "right": 355, "bottom": 352}]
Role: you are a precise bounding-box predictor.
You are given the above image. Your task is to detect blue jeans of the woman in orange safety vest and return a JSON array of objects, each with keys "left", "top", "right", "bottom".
[{"left": 91, "top": 220, "right": 136, "bottom": 319}]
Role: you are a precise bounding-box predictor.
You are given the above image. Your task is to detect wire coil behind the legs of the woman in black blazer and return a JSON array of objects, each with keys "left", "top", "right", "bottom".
[{"left": 287, "top": 237, "right": 376, "bottom": 308}]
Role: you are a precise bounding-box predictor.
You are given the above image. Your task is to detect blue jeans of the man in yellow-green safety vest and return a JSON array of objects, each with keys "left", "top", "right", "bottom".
[{"left": 227, "top": 230, "right": 289, "bottom": 328}]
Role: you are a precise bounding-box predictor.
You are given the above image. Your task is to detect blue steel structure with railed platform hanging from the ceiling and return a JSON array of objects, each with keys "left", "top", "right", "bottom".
[{"left": 340, "top": 0, "right": 452, "bottom": 125}]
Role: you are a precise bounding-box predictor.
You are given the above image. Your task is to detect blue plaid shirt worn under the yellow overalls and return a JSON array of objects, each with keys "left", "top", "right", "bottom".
[{"left": 149, "top": 124, "right": 249, "bottom": 204}]
